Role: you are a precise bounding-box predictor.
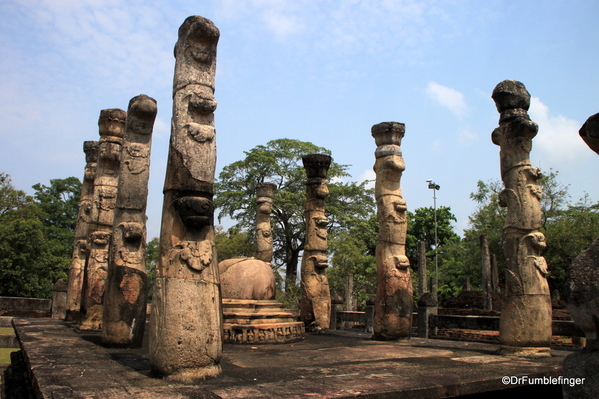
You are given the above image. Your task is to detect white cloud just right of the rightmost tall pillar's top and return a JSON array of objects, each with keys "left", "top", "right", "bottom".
[{"left": 529, "top": 97, "right": 594, "bottom": 170}]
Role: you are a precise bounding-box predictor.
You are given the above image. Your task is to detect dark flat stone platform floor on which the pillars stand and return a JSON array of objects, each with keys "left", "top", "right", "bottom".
[{"left": 8, "top": 319, "right": 570, "bottom": 399}]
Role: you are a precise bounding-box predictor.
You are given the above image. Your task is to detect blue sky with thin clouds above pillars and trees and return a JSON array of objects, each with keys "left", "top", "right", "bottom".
[{"left": 0, "top": 0, "right": 599, "bottom": 241}]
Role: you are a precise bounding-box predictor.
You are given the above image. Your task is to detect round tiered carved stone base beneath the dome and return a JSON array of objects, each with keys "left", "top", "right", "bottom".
[{"left": 223, "top": 299, "right": 305, "bottom": 344}]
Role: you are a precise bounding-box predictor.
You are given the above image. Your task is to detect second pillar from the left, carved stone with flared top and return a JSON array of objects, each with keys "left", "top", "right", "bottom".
[{"left": 79, "top": 108, "right": 127, "bottom": 330}]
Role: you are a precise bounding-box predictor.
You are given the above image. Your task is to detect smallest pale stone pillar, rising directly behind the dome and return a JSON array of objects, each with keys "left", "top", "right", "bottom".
[{"left": 256, "top": 183, "right": 277, "bottom": 263}]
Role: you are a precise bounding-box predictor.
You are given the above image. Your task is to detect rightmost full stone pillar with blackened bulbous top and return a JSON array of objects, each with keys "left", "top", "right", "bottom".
[{"left": 492, "top": 80, "right": 552, "bottom": 356}]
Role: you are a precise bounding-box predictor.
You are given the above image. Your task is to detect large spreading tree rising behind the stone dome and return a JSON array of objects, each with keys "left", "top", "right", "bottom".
[{"left": 215, "top": 139, "right": 374, "bottom": 289}]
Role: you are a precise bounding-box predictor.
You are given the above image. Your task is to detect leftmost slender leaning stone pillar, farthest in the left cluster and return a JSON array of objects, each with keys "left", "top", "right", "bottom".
[{"left": 65, "top": 141, "right": 98, "bottom": 322}]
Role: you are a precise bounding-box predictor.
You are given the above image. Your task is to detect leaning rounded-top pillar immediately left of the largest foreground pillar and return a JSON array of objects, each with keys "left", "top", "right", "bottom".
[{"left": 102, "top": 94, "right": 158, "bottom": 348}]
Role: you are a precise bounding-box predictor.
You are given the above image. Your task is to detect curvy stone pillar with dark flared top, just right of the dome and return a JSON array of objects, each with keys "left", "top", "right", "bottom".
[{"left": 300, "top": 154, "right": 331, "bottom": 332}]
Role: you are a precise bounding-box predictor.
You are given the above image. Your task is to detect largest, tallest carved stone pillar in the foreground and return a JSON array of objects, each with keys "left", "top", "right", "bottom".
[{"left": 149, "top": 16, "right": 223, "bottom": 382}]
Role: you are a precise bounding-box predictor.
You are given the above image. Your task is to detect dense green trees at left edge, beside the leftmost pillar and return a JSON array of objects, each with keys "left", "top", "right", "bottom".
[{"left": 0, "top": 173, "right": 81, "bottom": 298}]
